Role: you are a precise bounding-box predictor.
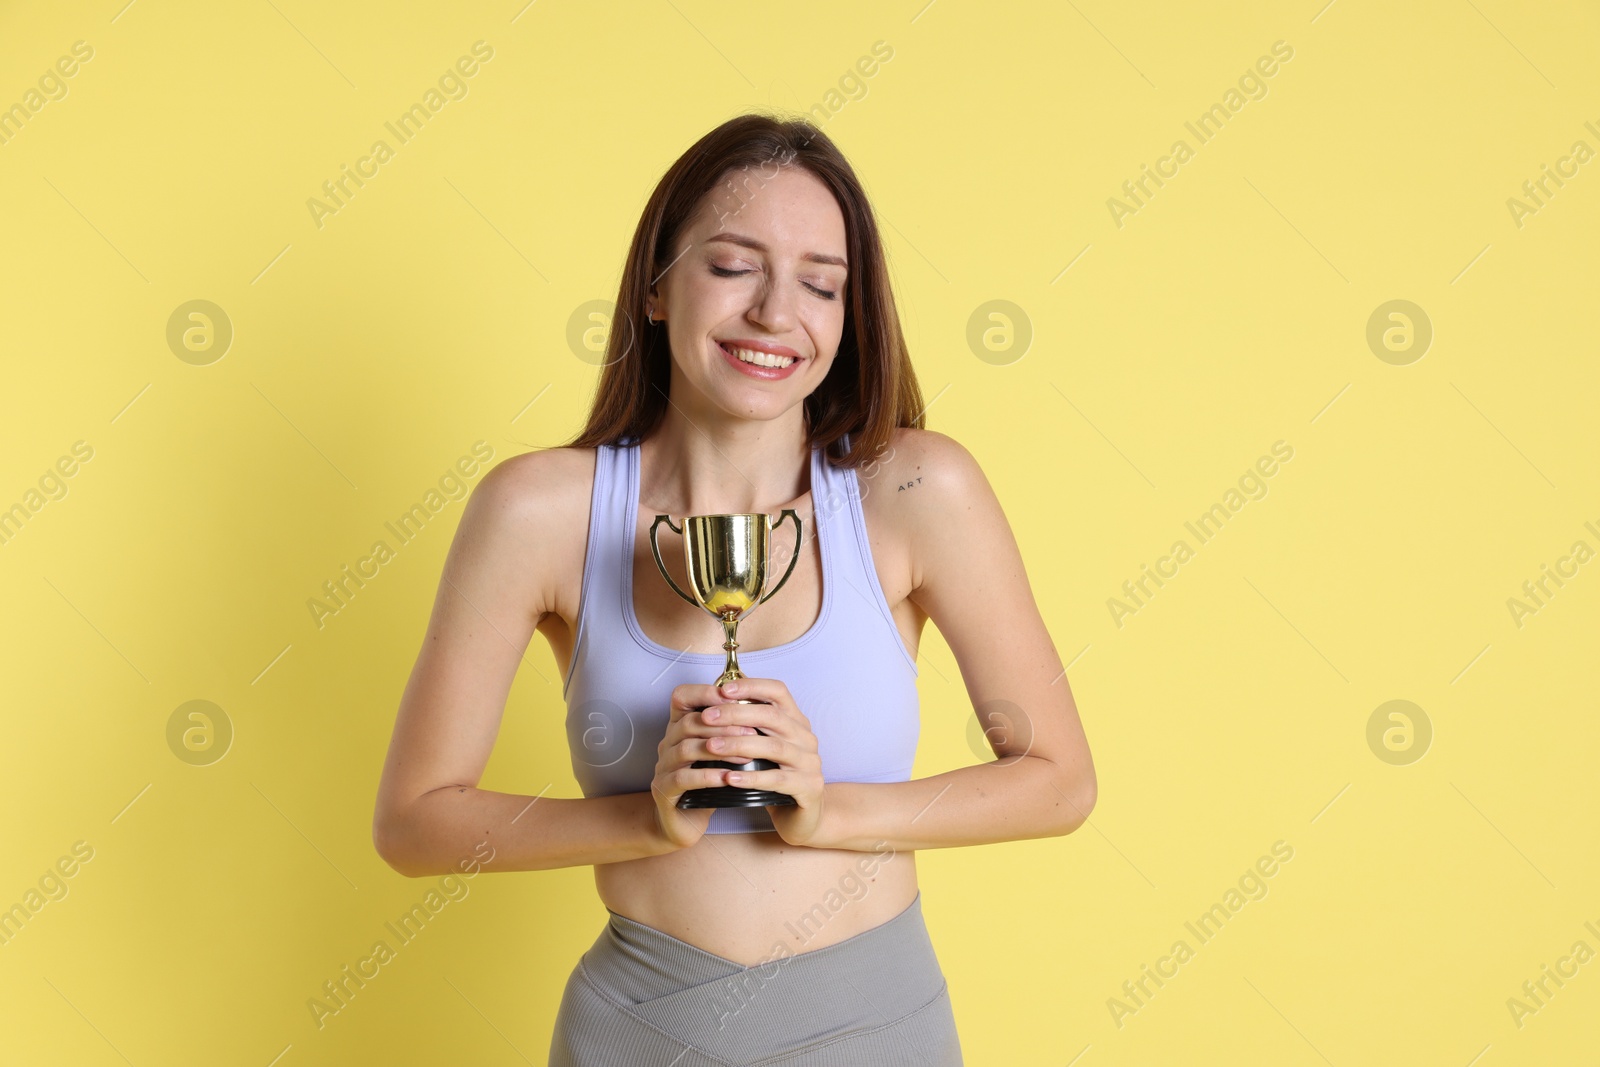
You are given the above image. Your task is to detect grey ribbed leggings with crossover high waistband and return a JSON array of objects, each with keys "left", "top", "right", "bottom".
[{"left": 550, "top": 891, "right": 962, "bottom": 1067}]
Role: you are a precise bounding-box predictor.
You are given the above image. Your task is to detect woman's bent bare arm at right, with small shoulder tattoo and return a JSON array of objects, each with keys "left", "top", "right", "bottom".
[{"left": 808, "top": 430, "right": 1096, "bottom": 851}]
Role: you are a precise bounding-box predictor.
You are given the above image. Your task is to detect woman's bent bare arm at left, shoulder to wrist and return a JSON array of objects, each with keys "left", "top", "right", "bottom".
[{"left": 373, "top": 450, "right": 682, "bottom": 878}]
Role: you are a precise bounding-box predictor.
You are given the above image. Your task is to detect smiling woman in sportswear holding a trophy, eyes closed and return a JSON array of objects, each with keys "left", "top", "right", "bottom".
[{"left": 374, "top": 115, "right": 1096, "bottom": 1067}]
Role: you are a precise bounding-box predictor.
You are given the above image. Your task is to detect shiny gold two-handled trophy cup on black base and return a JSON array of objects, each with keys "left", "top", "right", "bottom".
[{"left": 650, "top": 507, "right": 802, "bottom": 808}]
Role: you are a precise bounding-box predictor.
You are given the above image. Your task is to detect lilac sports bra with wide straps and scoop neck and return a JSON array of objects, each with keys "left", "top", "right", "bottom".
[{"left": 565, "top": 443, "right": 922, "bottom": 833}]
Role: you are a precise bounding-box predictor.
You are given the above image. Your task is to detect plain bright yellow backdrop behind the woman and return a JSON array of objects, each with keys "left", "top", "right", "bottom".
[{"left": 0, "top": 0, "right": 1600, "bottom": 1067}]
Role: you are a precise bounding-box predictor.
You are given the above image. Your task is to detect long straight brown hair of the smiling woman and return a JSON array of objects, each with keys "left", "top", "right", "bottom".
[{"left": 570, "top": 114, "right": 925, "bottom": 467}]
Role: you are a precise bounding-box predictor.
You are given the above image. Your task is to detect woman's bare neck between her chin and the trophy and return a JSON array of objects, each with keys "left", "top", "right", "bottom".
[{"left": 638, "top": 405, "right": 811, "bottom": 515}]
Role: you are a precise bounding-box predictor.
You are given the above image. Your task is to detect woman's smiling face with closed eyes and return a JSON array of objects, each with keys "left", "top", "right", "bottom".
[{"left": 651, "top": 163, "right": 848, "bottom": 421}]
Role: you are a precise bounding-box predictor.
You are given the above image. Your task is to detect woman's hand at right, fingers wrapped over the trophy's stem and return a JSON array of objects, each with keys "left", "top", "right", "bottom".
[{"left": 701, "top": 678, "right": 826, "bottom": 848}]
